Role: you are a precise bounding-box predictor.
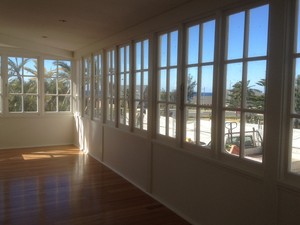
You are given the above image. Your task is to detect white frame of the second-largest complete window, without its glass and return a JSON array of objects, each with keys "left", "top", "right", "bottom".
[{"left": 183, "top": 17, "right": 217, "bottom": 153}]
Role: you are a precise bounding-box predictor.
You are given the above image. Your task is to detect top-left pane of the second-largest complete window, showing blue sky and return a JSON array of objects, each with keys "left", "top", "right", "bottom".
[{"left": 187, "top": 25, "right": 200, "bottom": 64}]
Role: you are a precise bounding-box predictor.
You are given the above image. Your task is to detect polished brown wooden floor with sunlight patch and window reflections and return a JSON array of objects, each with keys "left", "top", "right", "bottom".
[{"left": 0, "top": 146, "right": 189, "bottom": 225}]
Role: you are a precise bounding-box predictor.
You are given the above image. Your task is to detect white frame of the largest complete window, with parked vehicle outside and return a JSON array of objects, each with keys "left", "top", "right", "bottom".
[{"left": 219, "top": 3, "right": 270, "bottom": 165}]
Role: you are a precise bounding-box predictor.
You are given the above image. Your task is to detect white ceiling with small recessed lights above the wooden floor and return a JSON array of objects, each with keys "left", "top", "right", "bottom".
[{"left": 0, "top": 0, "right": 190, "bottom": 51}]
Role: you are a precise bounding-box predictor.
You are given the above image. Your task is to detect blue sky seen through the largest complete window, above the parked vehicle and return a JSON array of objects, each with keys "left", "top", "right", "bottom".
[{"left": 226, "top": 5, "right": 269, "bottom": 92}]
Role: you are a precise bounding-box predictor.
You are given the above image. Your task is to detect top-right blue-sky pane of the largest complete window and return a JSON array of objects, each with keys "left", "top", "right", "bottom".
[{"left": 248, "top": 5, "right": 269, "bottom": 57}]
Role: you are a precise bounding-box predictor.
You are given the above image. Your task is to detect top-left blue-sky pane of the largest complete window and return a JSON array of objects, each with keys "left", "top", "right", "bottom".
[{"left": 227, "top": 12, "right": 245, "bottom": 59}]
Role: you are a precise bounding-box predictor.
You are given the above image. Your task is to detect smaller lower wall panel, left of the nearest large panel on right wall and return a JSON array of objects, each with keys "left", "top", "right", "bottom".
[{"left": 103, "top": 127, "right": 151, "bottom": 191}]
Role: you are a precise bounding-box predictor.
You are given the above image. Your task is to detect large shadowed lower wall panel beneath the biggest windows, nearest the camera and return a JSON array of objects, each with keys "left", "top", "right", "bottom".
[{"left": 153, "top": 143, "right": 266, "bottom": 225}]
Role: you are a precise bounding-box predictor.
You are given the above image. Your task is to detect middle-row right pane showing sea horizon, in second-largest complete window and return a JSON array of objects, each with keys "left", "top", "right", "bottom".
[{"left": 200, "top": 66, "right": 214, "bottom": 105}]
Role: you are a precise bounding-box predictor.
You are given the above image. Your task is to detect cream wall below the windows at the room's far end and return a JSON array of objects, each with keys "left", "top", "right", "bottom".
[{"left": 0, "top": 114, "right": 74, "bottom": 149}]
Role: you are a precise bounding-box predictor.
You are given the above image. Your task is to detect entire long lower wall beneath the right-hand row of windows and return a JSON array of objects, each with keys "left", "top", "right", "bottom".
[{"left": 75, "top": 121, "right": 270, "bottom": 225}]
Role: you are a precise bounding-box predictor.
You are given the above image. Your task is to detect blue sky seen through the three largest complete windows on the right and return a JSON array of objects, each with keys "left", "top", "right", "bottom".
[{"left": 159, "top": 5, "right": 270, "bottom": 96}]
